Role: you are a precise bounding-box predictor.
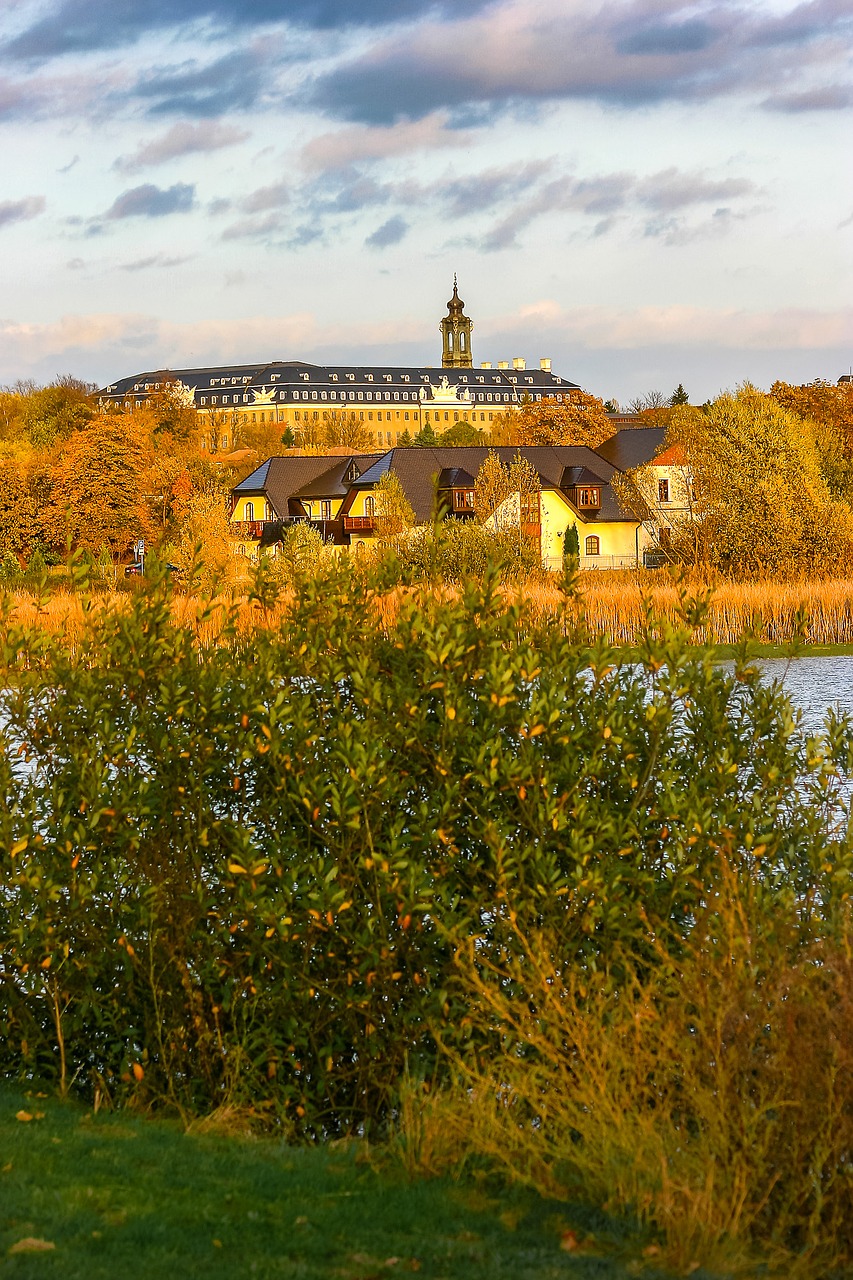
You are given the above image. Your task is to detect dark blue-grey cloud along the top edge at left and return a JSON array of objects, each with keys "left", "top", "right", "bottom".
[{"left": 6, "top": 0, "right": 488, "bottom": 60}]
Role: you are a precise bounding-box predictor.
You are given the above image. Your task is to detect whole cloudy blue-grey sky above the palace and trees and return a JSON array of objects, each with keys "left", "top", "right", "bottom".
[{"left": 0, "top": 0, "right": 853, "bottom": 404}]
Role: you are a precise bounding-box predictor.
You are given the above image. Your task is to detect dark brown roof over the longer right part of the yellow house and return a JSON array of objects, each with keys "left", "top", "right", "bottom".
[{"left": 352, "top": 444, "right": 617, "bottom": 522}]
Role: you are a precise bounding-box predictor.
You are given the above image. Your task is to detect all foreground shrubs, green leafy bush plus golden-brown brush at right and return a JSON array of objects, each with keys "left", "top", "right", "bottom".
[{"left": 0, "top": 563, "right": 853, "bottom": 1276}]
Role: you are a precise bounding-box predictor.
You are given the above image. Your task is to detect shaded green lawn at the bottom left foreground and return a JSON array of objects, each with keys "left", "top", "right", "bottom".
[{"left": 0, "top": 1085, "right": 686, "bottom": 1280}]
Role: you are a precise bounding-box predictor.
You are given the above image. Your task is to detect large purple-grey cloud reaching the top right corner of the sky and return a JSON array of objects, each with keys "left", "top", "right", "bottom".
[{"left": 307, "top": 0, "right": 853, "bottom": 127}]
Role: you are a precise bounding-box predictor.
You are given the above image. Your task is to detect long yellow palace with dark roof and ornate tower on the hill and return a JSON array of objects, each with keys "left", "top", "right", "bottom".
[{"left": 100, "top": 282, "right": 579, "bottom": 448}]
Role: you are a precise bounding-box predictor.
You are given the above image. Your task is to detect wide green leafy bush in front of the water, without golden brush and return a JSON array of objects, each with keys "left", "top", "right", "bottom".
[{"left": 0, "top": 564, "right": 852, "bottom": 1198}]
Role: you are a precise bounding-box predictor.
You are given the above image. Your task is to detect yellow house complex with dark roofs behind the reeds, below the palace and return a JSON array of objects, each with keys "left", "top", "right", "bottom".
[{"left": 231, "top": 428, "right": 689, "bottom": 568}]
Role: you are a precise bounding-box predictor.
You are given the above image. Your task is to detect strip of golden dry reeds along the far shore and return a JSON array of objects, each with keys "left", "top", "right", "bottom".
[{"left": 9, "top": 572, "right": 853, "bottom": 648}]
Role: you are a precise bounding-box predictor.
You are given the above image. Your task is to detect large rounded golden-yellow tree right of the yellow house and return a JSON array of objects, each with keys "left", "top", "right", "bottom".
[{"left": 670, "top": 385, "right": 853, "bottom": 575}]
